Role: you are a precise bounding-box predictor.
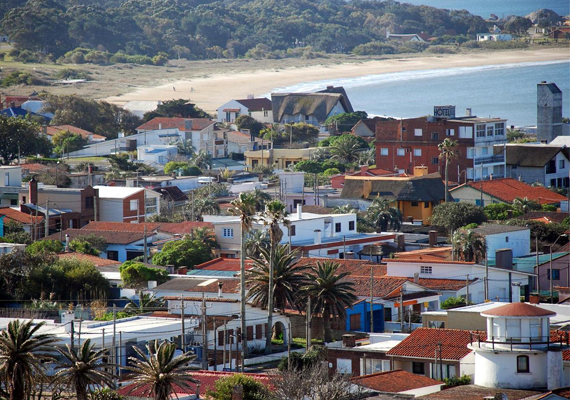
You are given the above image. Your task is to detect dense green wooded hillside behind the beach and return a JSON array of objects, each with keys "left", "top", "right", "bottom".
[{"left": 0, "top": 0, "right": 487, "bottom": 61}]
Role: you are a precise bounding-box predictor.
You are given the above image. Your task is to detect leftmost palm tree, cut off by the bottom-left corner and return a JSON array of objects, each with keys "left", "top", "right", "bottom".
[{"left": 0, "top": 320, "right": 59, "bottom": 400}]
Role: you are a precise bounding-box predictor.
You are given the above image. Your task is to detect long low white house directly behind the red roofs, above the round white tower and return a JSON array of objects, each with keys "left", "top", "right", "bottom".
[{"left": 384, "top": 259, "right": 535, "bottom": 304}]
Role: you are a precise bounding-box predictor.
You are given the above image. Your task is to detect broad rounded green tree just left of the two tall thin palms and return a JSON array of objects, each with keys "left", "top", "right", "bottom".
[{"left": 152, "top": 235, "right": 213, "bottom": 269}]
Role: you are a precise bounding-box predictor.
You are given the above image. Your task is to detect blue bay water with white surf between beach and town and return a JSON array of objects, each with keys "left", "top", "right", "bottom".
[{"left": 274, "top": 61, "right": 570, "bottom": 126}]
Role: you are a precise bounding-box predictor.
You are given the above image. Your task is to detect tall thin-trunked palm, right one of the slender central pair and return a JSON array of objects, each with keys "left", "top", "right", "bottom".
[{"left": 263, "top": 200, "right": 289, "bottom": 354}]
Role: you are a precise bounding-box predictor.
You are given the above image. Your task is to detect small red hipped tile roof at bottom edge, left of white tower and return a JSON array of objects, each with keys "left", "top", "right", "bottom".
[{"left": 352, "top": 369, "right": 444, "bottom": 393}]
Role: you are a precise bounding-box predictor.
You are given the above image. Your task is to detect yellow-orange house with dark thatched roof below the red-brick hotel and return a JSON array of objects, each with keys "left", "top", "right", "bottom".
[{"left": 340, "top": 167, "right": 445, "bottom": 225}]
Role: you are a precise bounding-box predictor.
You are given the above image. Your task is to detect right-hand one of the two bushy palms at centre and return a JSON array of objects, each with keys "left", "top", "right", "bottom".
[{"left": 306, "top": 261, "right": 357, "bottom": 342}]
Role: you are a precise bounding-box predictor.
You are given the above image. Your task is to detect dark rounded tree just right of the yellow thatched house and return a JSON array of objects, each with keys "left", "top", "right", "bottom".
[{"left": 431, "top": 201, "right": 487, "bottom": 233}]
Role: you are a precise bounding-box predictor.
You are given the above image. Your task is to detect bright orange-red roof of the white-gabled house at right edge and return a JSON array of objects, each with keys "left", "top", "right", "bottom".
[{"left": 450, "top": 178, "right": 566, "bottom": 204}]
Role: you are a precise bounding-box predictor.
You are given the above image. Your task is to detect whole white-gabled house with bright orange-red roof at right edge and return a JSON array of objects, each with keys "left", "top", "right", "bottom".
[{"left": 449, "top": 178, "right": 567, "bottom": 206}]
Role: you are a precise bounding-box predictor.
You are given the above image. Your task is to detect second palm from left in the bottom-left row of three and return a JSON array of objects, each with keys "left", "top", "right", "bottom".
[{"left": 54, "top": 339, "right": 115, "bottom": 400}]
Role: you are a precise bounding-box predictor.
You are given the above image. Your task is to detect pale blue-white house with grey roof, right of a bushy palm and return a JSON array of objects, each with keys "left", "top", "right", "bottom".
[{"left": 473, "top": 224, "right": 530, "bottom": 260}]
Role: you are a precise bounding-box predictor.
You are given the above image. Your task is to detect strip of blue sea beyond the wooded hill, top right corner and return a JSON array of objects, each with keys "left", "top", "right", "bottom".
[{"left": 400, "top": 0, "right": 570, "bottom": 18}]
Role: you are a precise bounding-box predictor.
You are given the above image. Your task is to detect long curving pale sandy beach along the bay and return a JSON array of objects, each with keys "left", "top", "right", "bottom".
[{"left": 105, "top": 48, "right": 570, "bottom": 112}]
